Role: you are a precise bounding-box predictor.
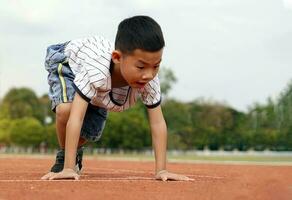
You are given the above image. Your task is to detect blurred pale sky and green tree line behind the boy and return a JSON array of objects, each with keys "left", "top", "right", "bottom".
[{"left": 0, "top": 0, "right": 292, "bottom": 155}]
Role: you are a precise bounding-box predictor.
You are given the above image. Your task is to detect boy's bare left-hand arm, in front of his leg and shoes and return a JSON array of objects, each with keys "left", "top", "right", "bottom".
[{"left": 43, "top": 92, "right": 88, "bottom": 180}]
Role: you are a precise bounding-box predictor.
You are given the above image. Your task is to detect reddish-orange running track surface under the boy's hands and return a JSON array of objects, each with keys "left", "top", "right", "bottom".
[{"left": 0, "top": 156, "right": 292, "bottom": 200}]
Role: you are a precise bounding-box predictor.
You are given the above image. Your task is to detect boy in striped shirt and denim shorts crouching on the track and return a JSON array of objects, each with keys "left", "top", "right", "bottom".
[{"left": 42, "top": 16, "right": 191, "bottom": 181}]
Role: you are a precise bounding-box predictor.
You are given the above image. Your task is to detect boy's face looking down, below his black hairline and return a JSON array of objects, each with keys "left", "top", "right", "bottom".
[{"left": 112, "top": 49, "right": 163, "bottom": 88}]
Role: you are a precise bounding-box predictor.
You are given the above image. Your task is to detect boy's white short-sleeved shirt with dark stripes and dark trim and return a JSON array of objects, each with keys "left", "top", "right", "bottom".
[{"left": 64, "top": 36, "right": 161, "bottom": 112}]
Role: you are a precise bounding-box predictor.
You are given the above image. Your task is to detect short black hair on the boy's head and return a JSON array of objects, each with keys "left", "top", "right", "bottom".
[{"left": 115, "top": 15, "right": 165, "bottom": 54}]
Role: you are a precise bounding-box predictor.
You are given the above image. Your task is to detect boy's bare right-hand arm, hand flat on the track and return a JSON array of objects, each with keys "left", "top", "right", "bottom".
[{"left": 148, "top": 105, "right": 192, "bottom": 181}]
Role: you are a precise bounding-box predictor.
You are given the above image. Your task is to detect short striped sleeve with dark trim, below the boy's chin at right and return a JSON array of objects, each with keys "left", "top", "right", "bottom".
[{"left": 141, "top": 75, "right": 161, "bottom": 108}]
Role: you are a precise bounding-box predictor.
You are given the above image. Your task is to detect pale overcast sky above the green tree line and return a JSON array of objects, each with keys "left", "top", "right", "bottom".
[{"left": 0, "top": 0, "right": 292, "bottom": 111}]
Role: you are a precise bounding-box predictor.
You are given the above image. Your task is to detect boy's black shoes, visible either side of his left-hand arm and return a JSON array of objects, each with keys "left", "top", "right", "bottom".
[{"left": 51, "top": 147, "right": 83, "bottom": 174}]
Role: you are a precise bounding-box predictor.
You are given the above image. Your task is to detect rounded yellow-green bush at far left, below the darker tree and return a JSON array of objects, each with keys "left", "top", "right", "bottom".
[{"left": 10, "top": 118, "right": 46, "bottom": 147}]
